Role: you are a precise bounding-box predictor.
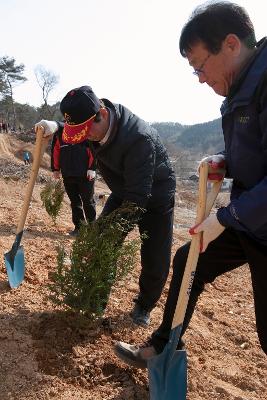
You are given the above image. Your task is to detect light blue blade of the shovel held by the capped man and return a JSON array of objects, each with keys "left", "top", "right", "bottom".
[{"left": 4, "top": 246, "right": 25, "bottom": 288}]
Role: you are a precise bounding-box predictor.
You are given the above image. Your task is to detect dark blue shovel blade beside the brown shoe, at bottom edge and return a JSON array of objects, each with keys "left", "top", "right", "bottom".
[{"left": 148, "top": 346, "right": 187, "bottom": 400}]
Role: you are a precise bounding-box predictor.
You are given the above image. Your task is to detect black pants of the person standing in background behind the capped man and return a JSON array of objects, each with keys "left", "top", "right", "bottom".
[{"left": 63, "top": 177, "right": 96, "bottom": 229}]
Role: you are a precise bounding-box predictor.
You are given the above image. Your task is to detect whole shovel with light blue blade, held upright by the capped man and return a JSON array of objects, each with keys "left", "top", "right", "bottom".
[{"left": 4, "top": 128, "right": 49, "bottom": 288}]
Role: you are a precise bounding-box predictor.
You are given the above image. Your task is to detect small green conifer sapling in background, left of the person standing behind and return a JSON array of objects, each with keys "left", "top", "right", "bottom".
[{"left": 40, "top": 179, "right": 65, "bottom": 223}]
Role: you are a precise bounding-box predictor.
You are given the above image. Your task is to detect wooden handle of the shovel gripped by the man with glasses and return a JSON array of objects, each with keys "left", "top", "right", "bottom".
[{"left": 172, "top": 163, "right": 223, "bottom": 329}]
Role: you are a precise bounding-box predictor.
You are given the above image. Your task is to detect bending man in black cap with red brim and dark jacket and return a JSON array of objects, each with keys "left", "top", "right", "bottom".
[{"left": 36, "top": 86, "right": 176, "bottom": 326}]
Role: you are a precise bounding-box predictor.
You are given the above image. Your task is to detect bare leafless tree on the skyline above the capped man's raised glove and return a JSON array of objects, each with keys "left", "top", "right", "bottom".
[{"left": 34, "top": 65, "right": 59, "bottom": 119}]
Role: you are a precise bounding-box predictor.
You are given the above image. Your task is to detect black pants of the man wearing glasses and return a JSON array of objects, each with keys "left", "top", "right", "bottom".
[{"left": 151, "top": 229, "right": 267, "bottom": 354}]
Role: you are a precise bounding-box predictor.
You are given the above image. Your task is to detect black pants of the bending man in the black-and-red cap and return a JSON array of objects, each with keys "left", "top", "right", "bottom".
[{"left": 102, "top": 195, "right": 174, "bottom": 311}]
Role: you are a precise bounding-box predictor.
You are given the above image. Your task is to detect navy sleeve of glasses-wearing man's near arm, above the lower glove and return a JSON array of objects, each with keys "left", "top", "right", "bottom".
[{"left": 217, "top": 81, "right": 267, "bottom": 233}]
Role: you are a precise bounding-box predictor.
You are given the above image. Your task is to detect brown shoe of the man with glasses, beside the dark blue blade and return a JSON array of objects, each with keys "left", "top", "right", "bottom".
[{"left": 115, "top": 342, "right": 157, "bottom": 369}]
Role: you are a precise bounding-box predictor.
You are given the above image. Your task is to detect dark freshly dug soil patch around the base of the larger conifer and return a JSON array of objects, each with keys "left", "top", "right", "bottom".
[{"left": 30, "top": 312, "right": 151, "bottom": 400}]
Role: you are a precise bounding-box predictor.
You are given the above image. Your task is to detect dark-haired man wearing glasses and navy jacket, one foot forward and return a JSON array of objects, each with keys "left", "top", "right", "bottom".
[{"left": 115, "top": 2, "right": 267, "bottom": 368}]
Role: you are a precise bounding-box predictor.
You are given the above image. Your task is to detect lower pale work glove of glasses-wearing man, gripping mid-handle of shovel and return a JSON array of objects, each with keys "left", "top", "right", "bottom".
[{"left": 189, "top": 214, "right": 225, "bottom": 253}]
